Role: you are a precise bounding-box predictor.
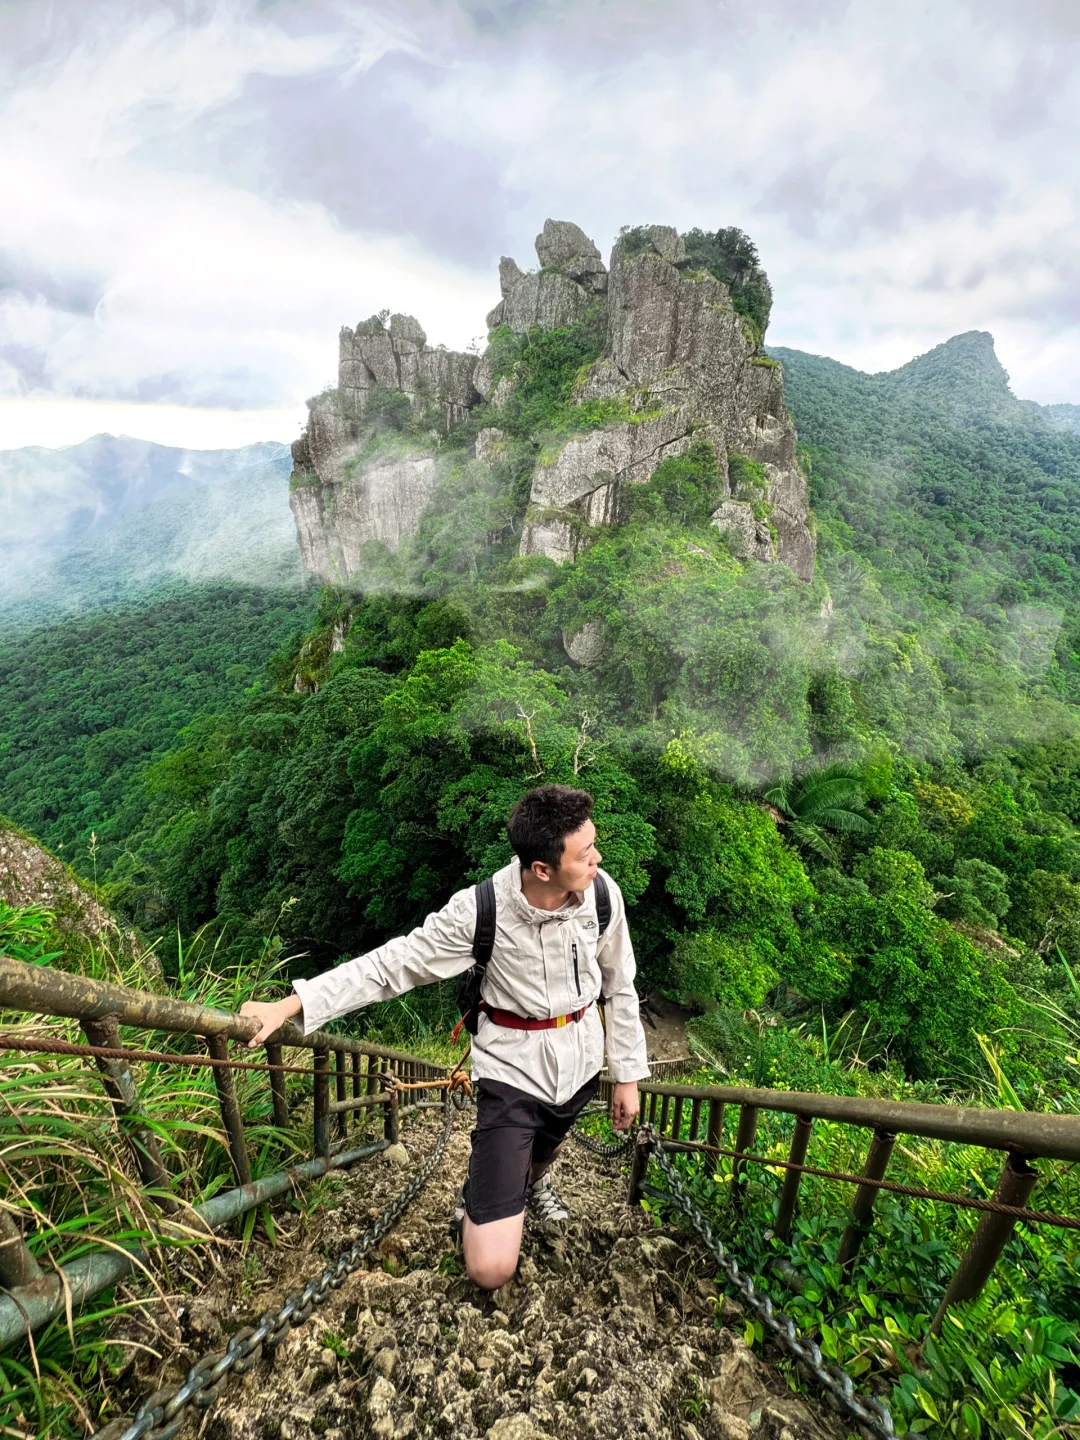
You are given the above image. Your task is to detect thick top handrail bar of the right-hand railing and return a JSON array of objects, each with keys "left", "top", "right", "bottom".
[{"left": 638, "top": 1080, "right": 1080, "bottom": 1161}]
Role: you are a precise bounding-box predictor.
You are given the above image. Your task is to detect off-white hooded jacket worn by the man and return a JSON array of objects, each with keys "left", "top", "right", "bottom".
[{"left": 295, "top": 860, "right": 649, "bottom": 1104}]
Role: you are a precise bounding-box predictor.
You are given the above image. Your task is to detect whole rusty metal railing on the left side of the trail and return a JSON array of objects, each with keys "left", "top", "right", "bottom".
[{"left": 0, "top": 956, "right": 449, "bottom": 1348}]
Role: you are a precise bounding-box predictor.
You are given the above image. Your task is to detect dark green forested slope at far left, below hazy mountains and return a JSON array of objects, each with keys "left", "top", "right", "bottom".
[{"left": 0, "top": 583, "right": 314, "bottom": 876}]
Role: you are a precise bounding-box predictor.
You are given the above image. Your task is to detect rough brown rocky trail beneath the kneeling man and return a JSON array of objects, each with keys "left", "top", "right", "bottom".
[{"left": 118, "top": 1110, "right": 842, "bottom": 1440}]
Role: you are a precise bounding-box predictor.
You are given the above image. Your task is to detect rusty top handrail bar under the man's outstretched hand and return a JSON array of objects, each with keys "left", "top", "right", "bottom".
[{"left": 0, "top": 955, "right": 446, "bottom": 1074}]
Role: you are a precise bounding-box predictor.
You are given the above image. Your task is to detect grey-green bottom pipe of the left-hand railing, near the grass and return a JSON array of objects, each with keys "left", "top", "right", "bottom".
[{"left": 0, "top": 1140, "right": 387, "bottom": 1349}]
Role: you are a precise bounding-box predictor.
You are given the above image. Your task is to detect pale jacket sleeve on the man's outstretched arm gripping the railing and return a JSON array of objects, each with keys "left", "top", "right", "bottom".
[{"left": 292, "top": 887, "right": 477, "bottom": 1035}]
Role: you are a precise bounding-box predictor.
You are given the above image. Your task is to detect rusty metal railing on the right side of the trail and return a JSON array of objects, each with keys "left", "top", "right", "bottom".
[{"left": 600, "top": 1080, "right": 1080, "bottom": 1333}]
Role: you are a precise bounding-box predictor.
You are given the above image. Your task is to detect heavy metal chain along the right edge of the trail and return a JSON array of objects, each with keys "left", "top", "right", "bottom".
[{"left": 638, "top": 1125, "right": 915, "bottom": 1440}]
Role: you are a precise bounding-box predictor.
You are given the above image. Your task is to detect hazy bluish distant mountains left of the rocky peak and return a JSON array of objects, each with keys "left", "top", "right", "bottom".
[{"left": 0, "top": 435, "right": 304, "bottom": 626}]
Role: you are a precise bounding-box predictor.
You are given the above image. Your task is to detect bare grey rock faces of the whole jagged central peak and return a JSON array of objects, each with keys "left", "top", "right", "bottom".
[{"left": 291, "top": 220, "right": 814, "bottom": 579}]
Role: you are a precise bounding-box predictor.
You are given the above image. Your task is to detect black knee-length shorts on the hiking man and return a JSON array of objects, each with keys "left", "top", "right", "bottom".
[{"left": 465, "top": 1074, "right": 600, "bottom": 1225}]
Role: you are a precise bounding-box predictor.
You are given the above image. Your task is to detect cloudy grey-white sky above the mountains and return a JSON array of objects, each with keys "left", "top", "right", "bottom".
[{"left": 0, "top": 0, "right": 1080, "bottom": 449}]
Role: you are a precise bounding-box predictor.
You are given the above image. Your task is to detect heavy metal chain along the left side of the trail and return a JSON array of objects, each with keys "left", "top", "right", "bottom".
[{"left": 94, "top": 1104, "right": 458, "bottom": 1440}]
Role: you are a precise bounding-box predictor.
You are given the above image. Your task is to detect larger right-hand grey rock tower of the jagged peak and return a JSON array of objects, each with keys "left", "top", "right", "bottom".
[{"left": 515, "top": 225, "right": 814, "bottom": 579}]
